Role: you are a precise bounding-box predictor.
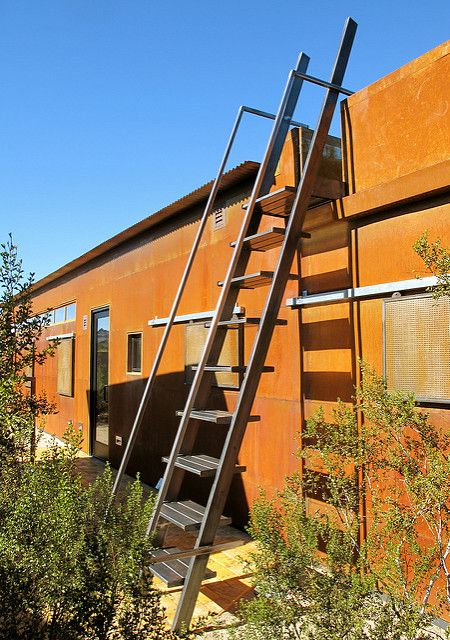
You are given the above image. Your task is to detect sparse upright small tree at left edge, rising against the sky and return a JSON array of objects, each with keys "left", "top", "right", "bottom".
[{"left": 0, "top": 236, "right": 54, "bottom": 459}]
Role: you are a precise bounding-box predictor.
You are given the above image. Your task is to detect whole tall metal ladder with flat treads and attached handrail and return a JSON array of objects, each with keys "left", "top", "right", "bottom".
[{"left": 113, "top": 18, "right": 357, "bottom": 629}]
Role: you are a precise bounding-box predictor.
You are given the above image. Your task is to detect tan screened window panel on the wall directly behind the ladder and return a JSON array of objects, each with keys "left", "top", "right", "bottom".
[{"left": 184, "top": 322, "right": 244, "bottom": 389}]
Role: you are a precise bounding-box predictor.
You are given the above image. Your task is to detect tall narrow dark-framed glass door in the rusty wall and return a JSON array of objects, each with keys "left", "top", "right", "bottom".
[{"left": 91, "top": 309, "right": 109, "bottom": 459}]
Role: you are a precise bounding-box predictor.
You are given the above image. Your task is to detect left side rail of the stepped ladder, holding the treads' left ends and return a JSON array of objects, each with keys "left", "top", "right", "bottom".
[{"left": 147, "top": 53, "right": 309, "bottom": 535}]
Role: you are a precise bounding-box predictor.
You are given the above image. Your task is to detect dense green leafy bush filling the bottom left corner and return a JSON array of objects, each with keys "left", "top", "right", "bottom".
[{"left": 0, "top": 424, "right": 176, "bottom": 640}]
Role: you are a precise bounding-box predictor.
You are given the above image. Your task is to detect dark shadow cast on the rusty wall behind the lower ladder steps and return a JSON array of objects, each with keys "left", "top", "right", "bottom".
[{"left": 92, "top": 371, "right": 249, "bottom": 527}]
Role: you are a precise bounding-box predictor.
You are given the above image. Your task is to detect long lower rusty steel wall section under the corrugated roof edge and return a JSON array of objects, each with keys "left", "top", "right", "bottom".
[{"left": 34, "top": 134, "right": 314, "bottom": 524}]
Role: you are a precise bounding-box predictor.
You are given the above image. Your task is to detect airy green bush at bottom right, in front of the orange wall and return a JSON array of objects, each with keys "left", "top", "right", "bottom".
[{"left": 232, "top": 367, "right": 450, "bottom": 640}]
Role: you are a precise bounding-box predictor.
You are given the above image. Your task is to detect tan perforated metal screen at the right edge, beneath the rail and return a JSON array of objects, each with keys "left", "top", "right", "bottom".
[{"left": 384, "top": 296, "right": 450, "bottom": 401}]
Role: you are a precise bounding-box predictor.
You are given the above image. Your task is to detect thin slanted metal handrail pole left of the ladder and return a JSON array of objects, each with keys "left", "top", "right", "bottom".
[{"left": 112, "top": 106, "right": 245, "bottom": 496}]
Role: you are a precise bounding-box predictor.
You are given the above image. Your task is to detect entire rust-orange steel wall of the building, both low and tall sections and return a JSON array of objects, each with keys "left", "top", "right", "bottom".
[{"left": 35, "top": 43, "right": 450, "bottom": 524}]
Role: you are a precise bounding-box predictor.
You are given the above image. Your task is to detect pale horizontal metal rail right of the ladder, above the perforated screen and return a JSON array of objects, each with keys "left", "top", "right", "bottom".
[{"left": 286, "top": 276, "right": 438, "bottom": 309}]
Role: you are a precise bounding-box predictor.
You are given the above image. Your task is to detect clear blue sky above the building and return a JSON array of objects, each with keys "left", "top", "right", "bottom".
[{"left": 0, "top": 0, "right": 450, "bottom": 277}]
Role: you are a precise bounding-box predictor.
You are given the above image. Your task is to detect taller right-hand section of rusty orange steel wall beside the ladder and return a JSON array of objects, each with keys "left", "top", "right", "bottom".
[{"left": 294, "top": 42, "right": 450, "bottom": 436}]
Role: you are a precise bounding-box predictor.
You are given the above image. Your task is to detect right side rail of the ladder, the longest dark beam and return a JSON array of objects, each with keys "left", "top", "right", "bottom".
[{"left": 173, "top": 18, "right": 357, "bottom": 630}]
